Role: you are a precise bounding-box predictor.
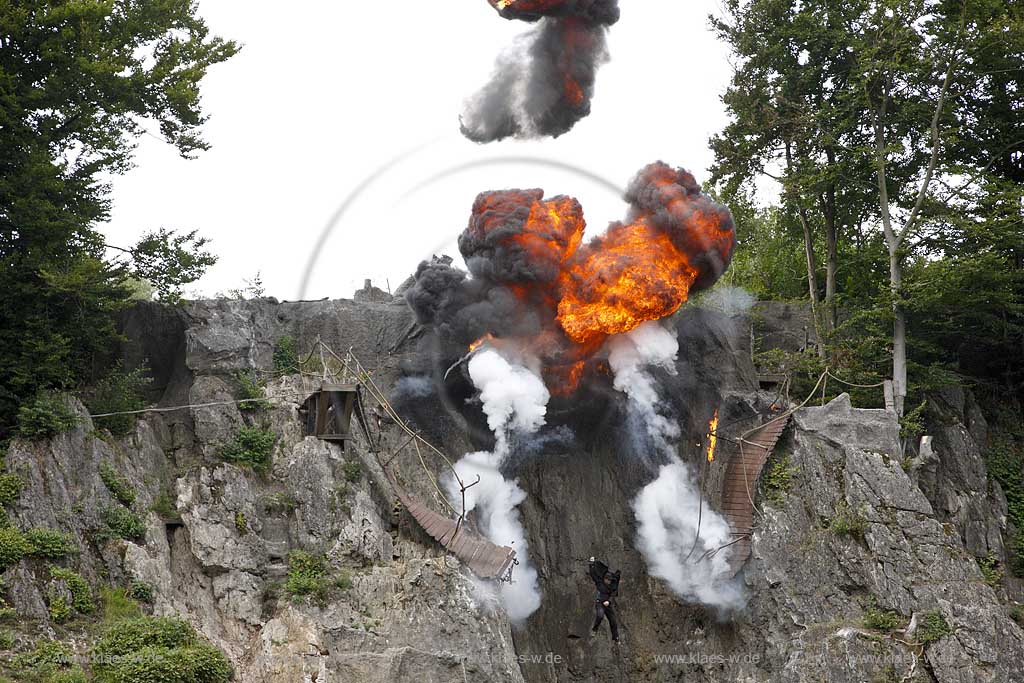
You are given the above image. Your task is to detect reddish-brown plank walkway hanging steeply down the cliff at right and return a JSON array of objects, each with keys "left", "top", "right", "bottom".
[{"left": 722, "top": 415, "right": 790, "bottom": 575}]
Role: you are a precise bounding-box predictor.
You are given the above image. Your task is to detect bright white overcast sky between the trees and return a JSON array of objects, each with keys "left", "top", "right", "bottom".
[{"left": 104, "top": 0, "right": 730, "bottom": 299}]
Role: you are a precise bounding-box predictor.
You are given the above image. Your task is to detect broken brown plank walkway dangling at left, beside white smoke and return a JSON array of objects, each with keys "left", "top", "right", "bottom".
[{"left": 392, "top": 481, "right": 516, "bottom": 581}]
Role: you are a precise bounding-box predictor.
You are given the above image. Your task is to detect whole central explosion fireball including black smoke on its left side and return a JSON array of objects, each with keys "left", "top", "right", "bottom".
[{"left": 407, "top": 161, "right": 735, "bottom": 395}]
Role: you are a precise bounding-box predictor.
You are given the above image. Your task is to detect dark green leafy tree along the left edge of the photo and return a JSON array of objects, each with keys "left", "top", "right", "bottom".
[{"left": 0, "top": 0, "right": 238, "bottom": 435}]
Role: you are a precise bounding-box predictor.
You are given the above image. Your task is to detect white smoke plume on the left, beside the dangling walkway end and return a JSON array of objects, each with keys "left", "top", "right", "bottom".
[{"left": 446, "top": 348, "right": 551, "bottom": 622}]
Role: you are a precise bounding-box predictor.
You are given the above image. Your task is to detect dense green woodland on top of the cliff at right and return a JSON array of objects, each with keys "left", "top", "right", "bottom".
[{"left": 711, "top": 0, "right": 1024, "bottom": 420}]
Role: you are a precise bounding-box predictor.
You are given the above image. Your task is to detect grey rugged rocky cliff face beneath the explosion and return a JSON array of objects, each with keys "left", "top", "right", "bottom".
[{"left": 4, "top": 293, "right": 1024, "bottom": 683}]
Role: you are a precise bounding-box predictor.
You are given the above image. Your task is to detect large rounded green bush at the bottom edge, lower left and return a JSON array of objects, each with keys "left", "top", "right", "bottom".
[{"left": 92, "top": 616, "right": 233, "bottom": 683}]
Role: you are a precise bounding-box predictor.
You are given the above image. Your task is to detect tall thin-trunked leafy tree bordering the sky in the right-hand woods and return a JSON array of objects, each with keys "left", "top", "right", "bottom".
[{"left": 711, "top": 0, "right": 867, "bottom": 353}]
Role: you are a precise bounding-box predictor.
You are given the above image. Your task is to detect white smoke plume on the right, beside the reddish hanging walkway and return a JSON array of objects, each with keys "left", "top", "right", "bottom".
[{"left": 608, "top": 322, "right": 743, "bottom": 608}]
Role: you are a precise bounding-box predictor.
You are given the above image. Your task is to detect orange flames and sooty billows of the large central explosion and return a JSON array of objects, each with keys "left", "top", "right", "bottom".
[{"left": 452, "top": 163, "right": 735, "bottom": 395}]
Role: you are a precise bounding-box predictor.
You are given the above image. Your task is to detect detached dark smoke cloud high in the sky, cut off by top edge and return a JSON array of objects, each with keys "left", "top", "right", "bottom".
[{"left": 461, "top": 0, "right": 618, "bottom": 142}]
